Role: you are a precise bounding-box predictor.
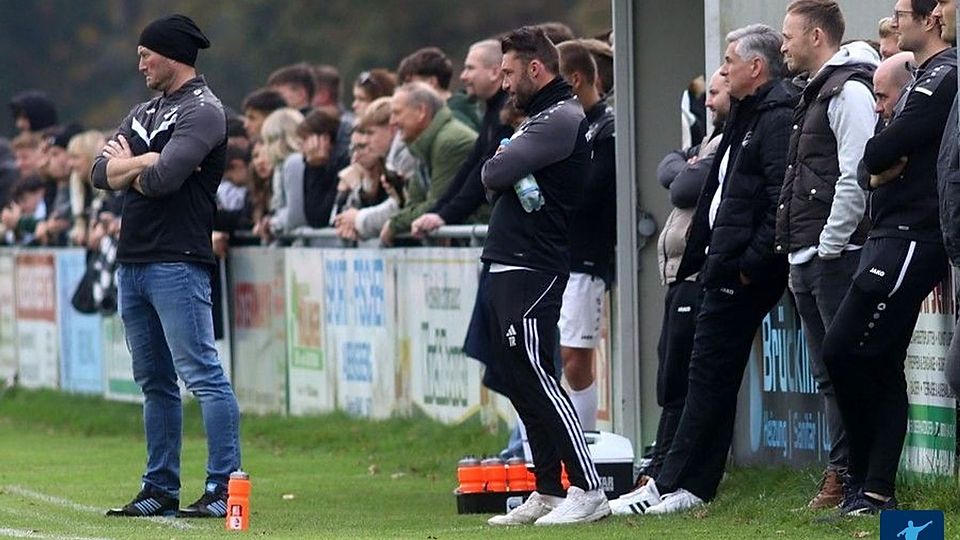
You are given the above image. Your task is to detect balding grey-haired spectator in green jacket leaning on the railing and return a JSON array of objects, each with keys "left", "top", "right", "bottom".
[{"left": 380, "top": 82, "right": 477, "bottom": 246}]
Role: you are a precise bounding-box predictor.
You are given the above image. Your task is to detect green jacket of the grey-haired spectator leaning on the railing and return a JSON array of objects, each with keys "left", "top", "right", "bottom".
[{"left": 390, "top": 107, "right": 477, "bottom": 234}]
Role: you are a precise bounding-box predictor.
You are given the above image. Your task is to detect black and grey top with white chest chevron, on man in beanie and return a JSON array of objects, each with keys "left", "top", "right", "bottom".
[{"left": 92, "top": 77, "right": 227, "bottom": 265}]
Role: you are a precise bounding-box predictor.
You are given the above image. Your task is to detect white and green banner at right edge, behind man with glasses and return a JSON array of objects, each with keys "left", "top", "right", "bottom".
[{"left": 900, "top": 278, "right": 957, "bottom": 477}]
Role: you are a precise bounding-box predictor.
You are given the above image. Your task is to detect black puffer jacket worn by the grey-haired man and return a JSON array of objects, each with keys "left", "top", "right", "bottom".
[{"left": 677, "top": 79, "right": 798, "bottom": 288}]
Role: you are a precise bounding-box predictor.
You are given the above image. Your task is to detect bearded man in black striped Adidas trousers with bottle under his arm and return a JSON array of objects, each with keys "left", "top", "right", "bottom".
[{"left": 481, "top": 27, "right": 610, "bottom": 525}]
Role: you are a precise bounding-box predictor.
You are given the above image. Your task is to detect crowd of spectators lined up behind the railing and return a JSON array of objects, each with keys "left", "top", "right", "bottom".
[{"left": 0, "top": 23, "right": 613, "bottom": 253}]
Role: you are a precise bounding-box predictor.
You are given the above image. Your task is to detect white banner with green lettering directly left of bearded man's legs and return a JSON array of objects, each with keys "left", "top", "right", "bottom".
[{"left": 397, "top": 248, "right": 488, "bottom": 423}]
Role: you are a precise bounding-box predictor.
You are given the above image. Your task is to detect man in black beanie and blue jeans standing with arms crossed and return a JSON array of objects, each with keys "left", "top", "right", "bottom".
[{"left": 93, "top": 15, "right": 240, "bottom": 517}]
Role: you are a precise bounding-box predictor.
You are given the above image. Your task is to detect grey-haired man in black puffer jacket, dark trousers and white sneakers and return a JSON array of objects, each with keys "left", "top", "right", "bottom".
[{"left": 616, "top": 24, "right": 796, "bottom": 514}]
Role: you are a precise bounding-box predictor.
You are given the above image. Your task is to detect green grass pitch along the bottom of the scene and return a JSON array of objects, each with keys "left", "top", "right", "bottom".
[{"left": 0, "top": 390, "right": 960, "bottom": 540}]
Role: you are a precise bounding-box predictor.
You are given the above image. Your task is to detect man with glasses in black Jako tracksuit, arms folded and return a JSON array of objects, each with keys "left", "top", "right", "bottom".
[{"left": 823, "top": 0, "right": 957, "bottom": 515}]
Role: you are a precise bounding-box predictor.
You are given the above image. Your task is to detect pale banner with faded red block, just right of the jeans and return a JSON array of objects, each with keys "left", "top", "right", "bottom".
[{"left": 230, "top": 247, "right": 287, "bottom": 414}]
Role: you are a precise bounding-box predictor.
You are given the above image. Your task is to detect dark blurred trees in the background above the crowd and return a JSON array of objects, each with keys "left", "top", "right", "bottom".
[{"left": 0, "top": 0, "right": 611, "bottom": 135}]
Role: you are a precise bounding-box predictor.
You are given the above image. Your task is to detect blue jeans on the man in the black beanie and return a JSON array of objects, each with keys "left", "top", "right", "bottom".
[{"left": 118, "top": 263, "right": 240, "bottom": 497}]
